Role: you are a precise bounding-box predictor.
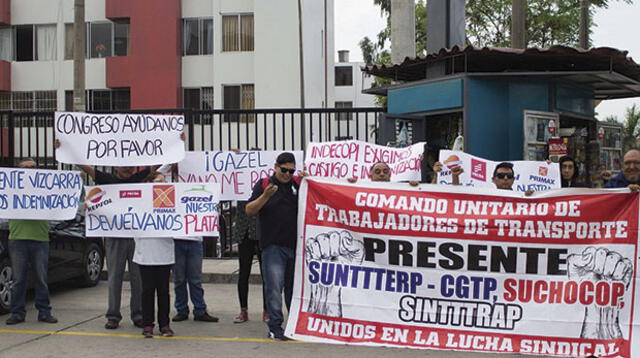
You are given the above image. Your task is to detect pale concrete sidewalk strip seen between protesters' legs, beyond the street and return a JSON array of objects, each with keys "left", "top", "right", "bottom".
[{"left": 101, "top": 257, "right": 262, "bottom": 284}]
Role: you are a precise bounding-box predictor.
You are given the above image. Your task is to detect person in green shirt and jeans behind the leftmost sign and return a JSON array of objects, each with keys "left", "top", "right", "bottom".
[{"left": 6, "top": 158, "right": 58, "bottom": 325}]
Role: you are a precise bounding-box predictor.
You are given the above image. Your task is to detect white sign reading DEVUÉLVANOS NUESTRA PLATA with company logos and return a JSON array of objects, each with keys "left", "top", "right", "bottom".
[{"left": 85, "top": 183, "right": 220, "bottom": 237}]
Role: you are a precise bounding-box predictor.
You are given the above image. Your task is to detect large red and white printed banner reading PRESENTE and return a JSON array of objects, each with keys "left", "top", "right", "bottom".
[{"left": 286, "top": 178, "right": 640, "bottom": 358}]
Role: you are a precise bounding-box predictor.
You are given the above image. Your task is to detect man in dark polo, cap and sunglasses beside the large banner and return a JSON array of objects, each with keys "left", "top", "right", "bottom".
[{"left": 245, "top": 152, "right": 300, "bottom": 340}]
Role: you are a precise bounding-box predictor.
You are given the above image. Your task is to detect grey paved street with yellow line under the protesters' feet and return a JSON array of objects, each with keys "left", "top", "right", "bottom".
[{"left": 0, "top": 281, "right": 544, "bottom": 358}]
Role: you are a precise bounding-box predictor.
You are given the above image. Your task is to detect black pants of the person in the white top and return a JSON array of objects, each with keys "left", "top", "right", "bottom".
[{"left": 139, "top": 265, "right": 173, "bottom": 328}]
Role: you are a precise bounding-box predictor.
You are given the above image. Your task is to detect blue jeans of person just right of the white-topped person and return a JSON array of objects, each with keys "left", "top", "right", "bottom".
[{"left": 173, "top": 240, "right": 207, "bottom": 317}]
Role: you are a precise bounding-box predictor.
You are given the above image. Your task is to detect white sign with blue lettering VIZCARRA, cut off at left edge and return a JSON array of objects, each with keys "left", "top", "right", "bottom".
[{"left": 0, "top": 168, "right": 82, "bottom": 220}]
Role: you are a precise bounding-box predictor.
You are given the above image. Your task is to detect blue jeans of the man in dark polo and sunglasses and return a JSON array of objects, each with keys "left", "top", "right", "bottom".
[{"left": 262, "top": 245, "right": 296, "bottom": 333}]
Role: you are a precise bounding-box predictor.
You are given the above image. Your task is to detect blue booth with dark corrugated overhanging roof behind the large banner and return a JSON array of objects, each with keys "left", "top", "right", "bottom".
[{"left": 363, "top": 46, "right": 640, "bottom": 183}]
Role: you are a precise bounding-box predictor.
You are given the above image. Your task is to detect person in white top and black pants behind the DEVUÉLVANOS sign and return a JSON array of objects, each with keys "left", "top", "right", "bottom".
[{"left": 133, "top": 172, "right": 175, "bottom": 338}]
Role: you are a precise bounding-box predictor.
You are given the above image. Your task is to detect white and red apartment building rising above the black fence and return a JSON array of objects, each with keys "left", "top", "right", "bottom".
[{"left": 0, "top": 0, "right": 334, "bottom": 111}]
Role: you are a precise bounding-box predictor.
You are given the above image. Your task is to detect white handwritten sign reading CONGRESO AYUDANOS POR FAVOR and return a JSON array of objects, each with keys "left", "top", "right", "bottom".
[{"left": 54, "top": 112, "right": 185, "bottom": 166}]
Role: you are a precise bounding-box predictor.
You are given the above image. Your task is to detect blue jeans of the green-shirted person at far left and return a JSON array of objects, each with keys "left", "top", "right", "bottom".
[{"left": 9, "top": 240, "right": 51, "bottom": 319}]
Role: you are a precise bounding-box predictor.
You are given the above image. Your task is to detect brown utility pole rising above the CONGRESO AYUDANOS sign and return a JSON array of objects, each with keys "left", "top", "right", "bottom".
[{"left": 73, "top": 0, "right": 86, "bottom": 112}]
